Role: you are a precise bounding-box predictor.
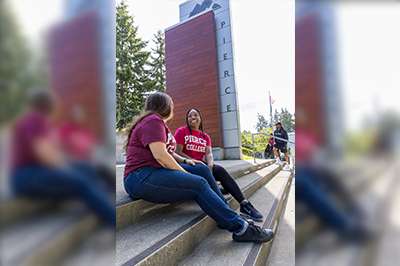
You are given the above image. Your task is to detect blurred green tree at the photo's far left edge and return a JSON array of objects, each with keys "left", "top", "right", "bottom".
[{"left": 0, "top": 1, "right": 46, "bottom": 124}]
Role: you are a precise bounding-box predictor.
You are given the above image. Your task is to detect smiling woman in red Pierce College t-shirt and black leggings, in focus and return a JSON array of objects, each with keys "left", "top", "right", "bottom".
[{"left": 175, "top": 109, "right": 263, "bottom": 221}]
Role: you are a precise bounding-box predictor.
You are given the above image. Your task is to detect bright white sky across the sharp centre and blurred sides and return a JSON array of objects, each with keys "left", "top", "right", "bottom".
[{"left": 11, "top": 0, "right": 400, "bottom": 132}]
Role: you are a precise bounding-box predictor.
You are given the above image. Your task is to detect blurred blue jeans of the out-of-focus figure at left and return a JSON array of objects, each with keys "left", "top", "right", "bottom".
[{"left": 11, "top": 163, "right": 116, "bottom": 226}]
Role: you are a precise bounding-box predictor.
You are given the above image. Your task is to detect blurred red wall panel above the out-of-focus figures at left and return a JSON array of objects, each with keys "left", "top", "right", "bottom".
[{"left": 49, "top": 12, "right": 104, "bottom": 138}]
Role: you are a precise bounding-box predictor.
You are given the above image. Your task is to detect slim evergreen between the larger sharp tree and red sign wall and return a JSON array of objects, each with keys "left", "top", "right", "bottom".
[{"left": 150, "top": 30, "right": 166, "bottom": 92}]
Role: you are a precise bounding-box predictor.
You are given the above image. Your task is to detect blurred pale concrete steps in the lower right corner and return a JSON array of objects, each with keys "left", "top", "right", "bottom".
[{"left": 296, "top": 159, "right": 400, "bottom": 266}]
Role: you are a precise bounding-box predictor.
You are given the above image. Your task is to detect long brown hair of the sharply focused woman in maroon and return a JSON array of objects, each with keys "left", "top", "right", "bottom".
[{"left": 122, "top": 92, "right": 174, "bottom": 155}]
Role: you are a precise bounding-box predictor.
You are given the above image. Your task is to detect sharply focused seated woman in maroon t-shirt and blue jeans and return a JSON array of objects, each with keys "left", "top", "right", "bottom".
[{"left": 124, "top": 92, "right": 273, "bottom": 242}]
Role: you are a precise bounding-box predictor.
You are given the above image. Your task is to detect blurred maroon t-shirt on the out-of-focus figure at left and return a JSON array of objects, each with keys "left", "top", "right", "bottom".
[{"left": 11, "top": 112, "right": 52, "bottom": 170}]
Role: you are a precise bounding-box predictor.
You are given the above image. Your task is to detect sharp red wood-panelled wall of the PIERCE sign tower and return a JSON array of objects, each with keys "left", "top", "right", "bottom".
[{"left": 165, "top": 11, "right": 222, "bottom": 147}]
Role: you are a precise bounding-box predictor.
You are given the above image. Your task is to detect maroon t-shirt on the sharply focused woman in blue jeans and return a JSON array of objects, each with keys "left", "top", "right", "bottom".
[{"left": 124, "top": 114, "right": 176, "bottom": 178}]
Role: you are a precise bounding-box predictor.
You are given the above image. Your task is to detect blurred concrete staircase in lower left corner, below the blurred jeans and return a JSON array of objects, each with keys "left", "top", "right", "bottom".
[{"left": 0, "top": 199, "right": 98, "bottom": 266}]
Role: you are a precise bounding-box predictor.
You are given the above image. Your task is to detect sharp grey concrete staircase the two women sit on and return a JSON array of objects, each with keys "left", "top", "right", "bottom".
[{"left": 116, "top": 160, "right": 294, "bottom": 265}]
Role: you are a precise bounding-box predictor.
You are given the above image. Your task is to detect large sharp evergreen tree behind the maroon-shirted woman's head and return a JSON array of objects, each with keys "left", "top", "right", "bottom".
[{"left": 116, "top": 0, "right": 154, "bottom": 130}]
